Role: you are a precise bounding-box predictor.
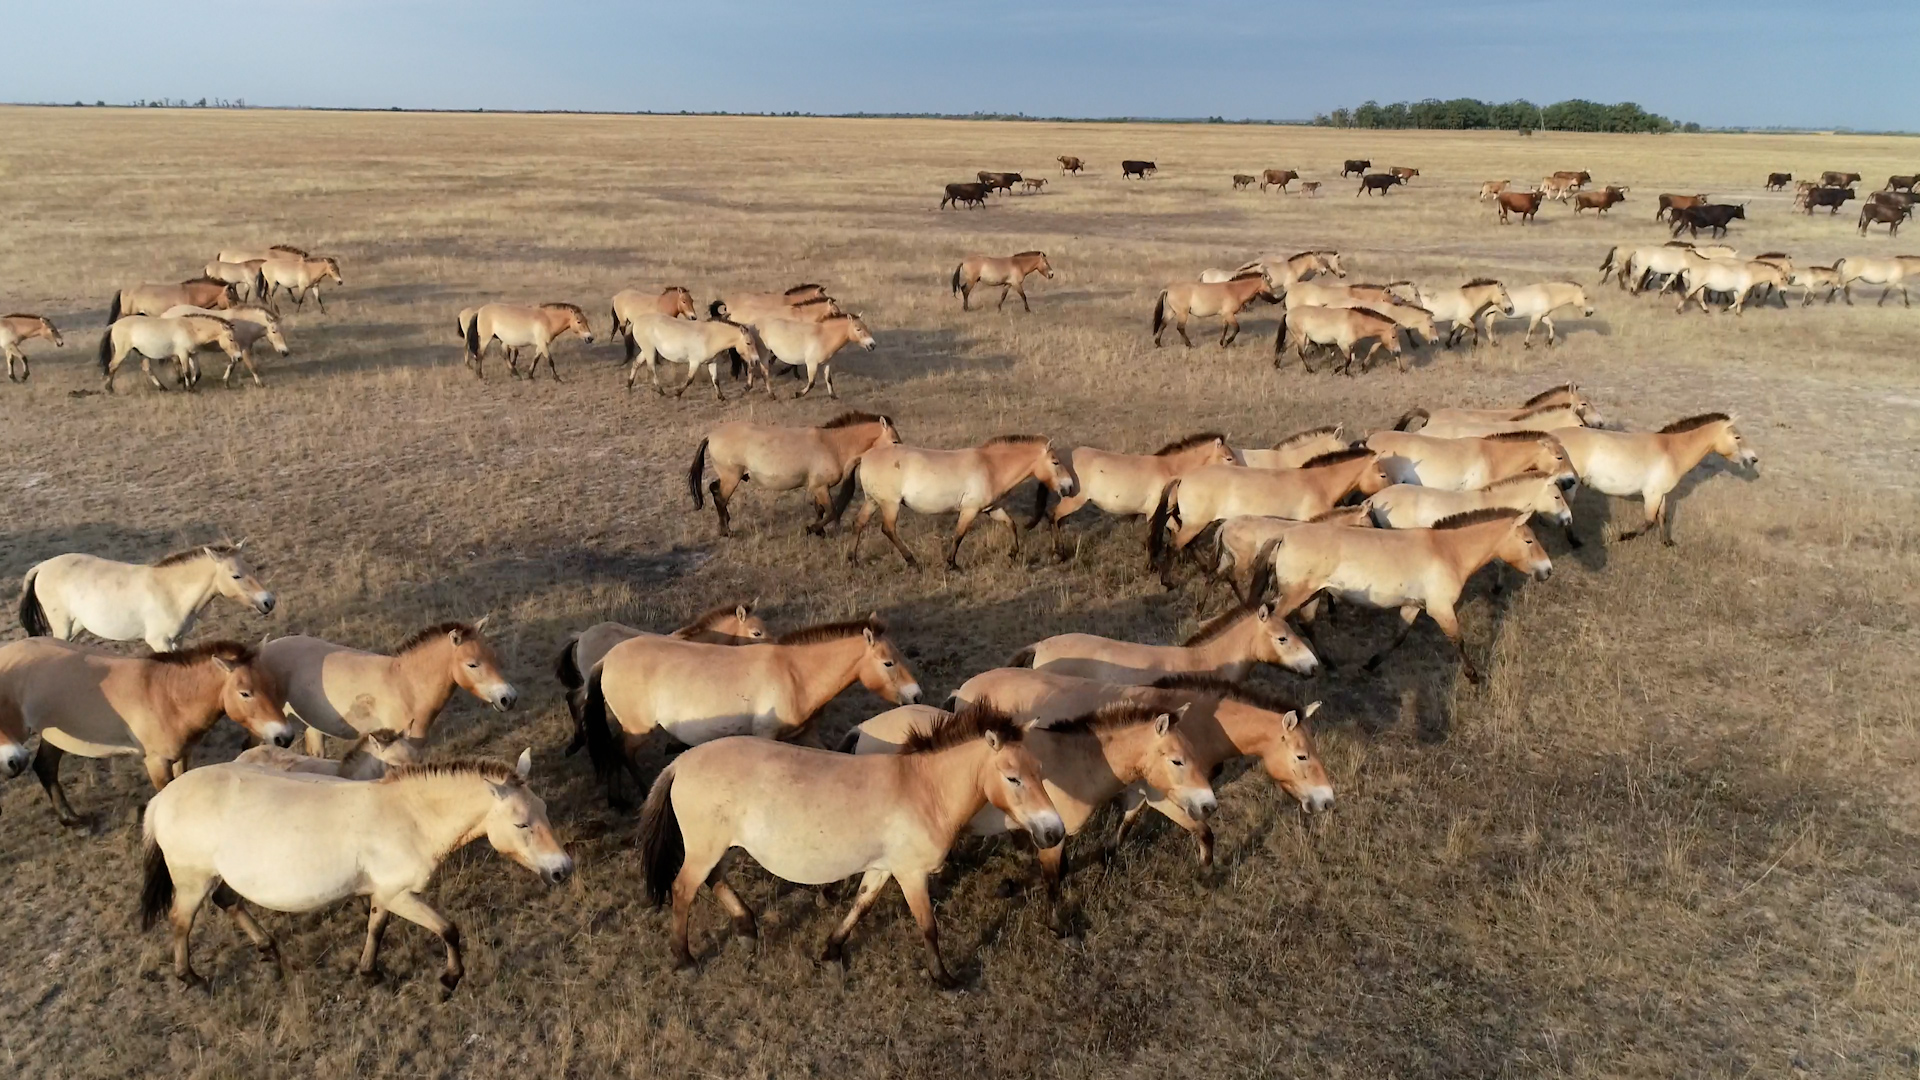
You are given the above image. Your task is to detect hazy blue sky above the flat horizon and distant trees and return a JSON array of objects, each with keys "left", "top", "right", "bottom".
[{"left": 15, "top": 0, "right": 1920, "bottom": 131}]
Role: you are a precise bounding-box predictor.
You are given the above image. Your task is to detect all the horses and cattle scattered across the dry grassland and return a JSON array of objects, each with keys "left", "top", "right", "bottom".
[{"left": 0, "top": 138, "right": 1920, "bottom": 994}]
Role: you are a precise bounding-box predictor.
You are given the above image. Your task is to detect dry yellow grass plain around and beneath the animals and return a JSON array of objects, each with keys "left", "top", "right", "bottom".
[{"left": 0, "top": 110, "right": 1920, "bottom": 1078}]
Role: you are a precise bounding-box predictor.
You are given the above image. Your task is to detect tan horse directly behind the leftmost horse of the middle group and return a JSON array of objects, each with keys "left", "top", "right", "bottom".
[{"left": 847, "top": 434, "right": 1079, "bottom": 571}]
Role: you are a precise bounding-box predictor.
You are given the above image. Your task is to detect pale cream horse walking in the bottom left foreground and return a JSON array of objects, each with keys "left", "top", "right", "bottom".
[{"left": 140, "top": 751, "right": 574, "bottom": 999}]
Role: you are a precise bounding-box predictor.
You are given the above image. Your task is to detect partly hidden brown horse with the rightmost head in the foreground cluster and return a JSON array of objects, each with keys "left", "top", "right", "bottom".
[{"left": 954, "top": 667, "right": 1332, "bottom": 867}]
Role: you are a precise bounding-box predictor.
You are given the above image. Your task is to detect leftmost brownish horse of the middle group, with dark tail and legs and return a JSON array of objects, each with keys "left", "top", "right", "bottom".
[{"left": 687, "top": 413, "right": 900, "bottom": 536}]
